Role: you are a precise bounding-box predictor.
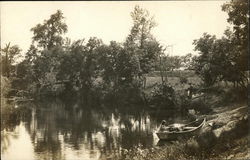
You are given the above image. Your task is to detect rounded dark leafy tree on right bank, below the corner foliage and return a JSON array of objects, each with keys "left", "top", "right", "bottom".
[{"left": 193, "top": 30, "right": 244, "bottom": 86}]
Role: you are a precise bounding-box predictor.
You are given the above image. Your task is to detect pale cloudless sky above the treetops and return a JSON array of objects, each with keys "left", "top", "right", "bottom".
[{"left": 0, "top": 0, "right": 230, "bottom": 56}]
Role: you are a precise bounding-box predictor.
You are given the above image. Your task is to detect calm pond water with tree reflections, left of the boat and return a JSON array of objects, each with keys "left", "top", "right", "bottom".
[{"left": 1, "top": 100, "right": 186, "bottom": 160}]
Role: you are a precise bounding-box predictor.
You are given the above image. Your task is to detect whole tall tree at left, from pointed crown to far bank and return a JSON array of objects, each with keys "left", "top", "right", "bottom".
[{"left": 17, "top": 10, "right": 67, "bottom": 93}]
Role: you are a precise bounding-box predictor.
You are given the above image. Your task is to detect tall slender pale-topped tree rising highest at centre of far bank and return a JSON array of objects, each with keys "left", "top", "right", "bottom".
[{"left": 124, "top": 6, "right": 162, "bottom": 77}]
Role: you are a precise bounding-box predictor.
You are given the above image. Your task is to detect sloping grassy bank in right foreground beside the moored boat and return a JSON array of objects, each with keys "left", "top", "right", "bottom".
[{"left": 107, "top": 94, "right": 250, "bottom": 160}]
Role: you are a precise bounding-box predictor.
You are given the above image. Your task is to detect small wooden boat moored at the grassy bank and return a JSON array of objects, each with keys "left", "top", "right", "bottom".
[{"left": 156, "top": 118, "right": 206, "bottom": 140}]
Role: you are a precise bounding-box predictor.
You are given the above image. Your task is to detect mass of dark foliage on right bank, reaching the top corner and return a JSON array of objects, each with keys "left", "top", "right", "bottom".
[{"left": 193, "top": 0, "right": 249, "bottom": 87}]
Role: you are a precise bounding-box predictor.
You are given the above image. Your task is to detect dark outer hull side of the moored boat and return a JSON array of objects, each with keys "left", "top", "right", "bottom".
[{"left": 156, "top": 119, "right": 206, "bottom": 140}]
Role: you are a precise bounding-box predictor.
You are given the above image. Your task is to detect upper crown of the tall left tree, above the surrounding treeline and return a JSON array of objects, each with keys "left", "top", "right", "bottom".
[{"left": 31, "top": 10, "right": 67, "bottom": 49}]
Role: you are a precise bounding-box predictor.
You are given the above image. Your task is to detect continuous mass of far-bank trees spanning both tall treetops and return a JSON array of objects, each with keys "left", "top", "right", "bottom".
[{"left": 2, "top": 6, "right": 165, "bottom": 99}]
